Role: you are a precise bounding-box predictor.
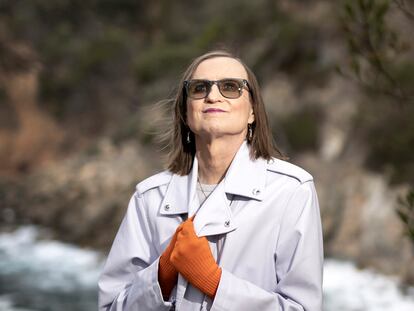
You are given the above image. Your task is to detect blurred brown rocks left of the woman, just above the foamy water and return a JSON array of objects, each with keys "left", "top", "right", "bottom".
[{"left": 0, "top": 139, "right": 160, "bottom": 249}]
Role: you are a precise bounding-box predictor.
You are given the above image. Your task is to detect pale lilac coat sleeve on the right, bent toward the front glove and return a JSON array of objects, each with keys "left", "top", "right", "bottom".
[{"left": 211, "top": 181, "right": 323, "bottom": 311}]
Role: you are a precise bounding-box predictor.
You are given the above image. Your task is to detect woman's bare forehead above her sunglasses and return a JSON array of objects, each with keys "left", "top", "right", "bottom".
[{"left": 192, "top": 57, "right": 248, "bottom": 80}]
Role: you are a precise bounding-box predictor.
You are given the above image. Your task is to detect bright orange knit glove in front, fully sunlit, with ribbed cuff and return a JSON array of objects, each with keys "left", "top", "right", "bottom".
[{"left": 170, "top": 218, "right": 221, "bottom": 298}]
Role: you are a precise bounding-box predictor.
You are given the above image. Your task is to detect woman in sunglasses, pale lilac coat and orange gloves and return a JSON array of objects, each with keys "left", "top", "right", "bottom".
[{"left": 99, "top": 51, "right": 323, "bottom": 311}]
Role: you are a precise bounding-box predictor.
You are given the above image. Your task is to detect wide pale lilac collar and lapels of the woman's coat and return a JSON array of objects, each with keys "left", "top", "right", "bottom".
[{"left": 160, "top": 142, "right": 267, "bottom": 236}]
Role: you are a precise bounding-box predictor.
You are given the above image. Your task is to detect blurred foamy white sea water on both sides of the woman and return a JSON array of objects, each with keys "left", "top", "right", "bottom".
[{"left": 0, "top": 227, "right": 414, "bottom": 311}]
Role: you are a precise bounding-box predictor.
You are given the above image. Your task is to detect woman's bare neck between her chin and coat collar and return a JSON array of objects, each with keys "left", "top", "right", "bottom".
[{"left": 196, "top": 137, "right": 243, "bottom": 184}]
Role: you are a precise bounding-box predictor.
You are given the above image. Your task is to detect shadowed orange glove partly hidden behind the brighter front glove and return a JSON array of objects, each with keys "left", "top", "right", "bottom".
[{"left": 158, "top": 216, "right": 194, "bottom": 300}]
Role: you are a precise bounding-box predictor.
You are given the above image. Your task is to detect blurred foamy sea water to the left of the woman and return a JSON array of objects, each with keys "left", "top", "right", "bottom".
[{"left": 0, "top": 227, "right": 102, "bottom": 311}]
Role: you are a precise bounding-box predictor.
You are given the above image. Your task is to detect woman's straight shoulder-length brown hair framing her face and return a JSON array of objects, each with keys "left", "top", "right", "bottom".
[{"left": 163, "top": 51, "right": 285, "bottom": 175}]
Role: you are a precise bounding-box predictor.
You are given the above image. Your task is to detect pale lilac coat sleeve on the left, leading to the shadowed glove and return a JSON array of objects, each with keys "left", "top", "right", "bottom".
[{"left": 98, "top": 193, "right": 171, "bottom": 311}]
